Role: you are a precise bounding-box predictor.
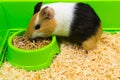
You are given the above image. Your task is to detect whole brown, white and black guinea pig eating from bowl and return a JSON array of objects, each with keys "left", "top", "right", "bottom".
[{"left": 25, "top": 2, "right": 102, "bottom": 50}]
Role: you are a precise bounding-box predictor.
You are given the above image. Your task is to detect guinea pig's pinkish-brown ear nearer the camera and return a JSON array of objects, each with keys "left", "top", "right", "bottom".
[{"left": 40, "top": 6, "right": 55, "bottom": 19}]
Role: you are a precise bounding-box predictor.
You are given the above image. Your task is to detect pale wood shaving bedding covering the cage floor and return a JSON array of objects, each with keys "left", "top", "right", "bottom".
[{"left": 0, "top": 33, "right": 120, "bottom": 80}]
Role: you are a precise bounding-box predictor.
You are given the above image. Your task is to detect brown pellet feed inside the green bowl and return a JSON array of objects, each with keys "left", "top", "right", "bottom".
[{"left": 13, "top": 36, "right": 51, "bottom": 50}]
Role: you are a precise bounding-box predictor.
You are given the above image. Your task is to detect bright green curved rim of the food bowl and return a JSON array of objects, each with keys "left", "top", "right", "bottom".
[{"left": 8, "top": 30, "right": 56, "bottom": 53}]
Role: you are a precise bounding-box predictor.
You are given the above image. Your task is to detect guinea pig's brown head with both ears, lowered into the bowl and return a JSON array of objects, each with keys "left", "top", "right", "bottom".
[{"left": 25, "top": 2, "right": 56, "bottom": 39}]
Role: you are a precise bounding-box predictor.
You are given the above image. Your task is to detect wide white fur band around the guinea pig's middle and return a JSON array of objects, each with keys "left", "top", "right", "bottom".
[{"left": 43, "top": 3, "right": 75, "bottom": 36}]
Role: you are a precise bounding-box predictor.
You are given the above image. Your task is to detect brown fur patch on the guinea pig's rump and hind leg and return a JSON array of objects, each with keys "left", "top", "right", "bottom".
[{"left": 82, "top": 26, "right": 102, "bottom": 51}]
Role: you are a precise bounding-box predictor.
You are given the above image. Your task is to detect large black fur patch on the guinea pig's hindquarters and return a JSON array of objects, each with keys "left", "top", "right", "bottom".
[{"left": 70, "top": 3, "right": 100, "bottom": 43}]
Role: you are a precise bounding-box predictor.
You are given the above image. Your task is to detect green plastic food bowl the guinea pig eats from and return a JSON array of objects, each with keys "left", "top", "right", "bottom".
[{"left": 7, "top": 30, "right": 60, "bottom": 70}]
